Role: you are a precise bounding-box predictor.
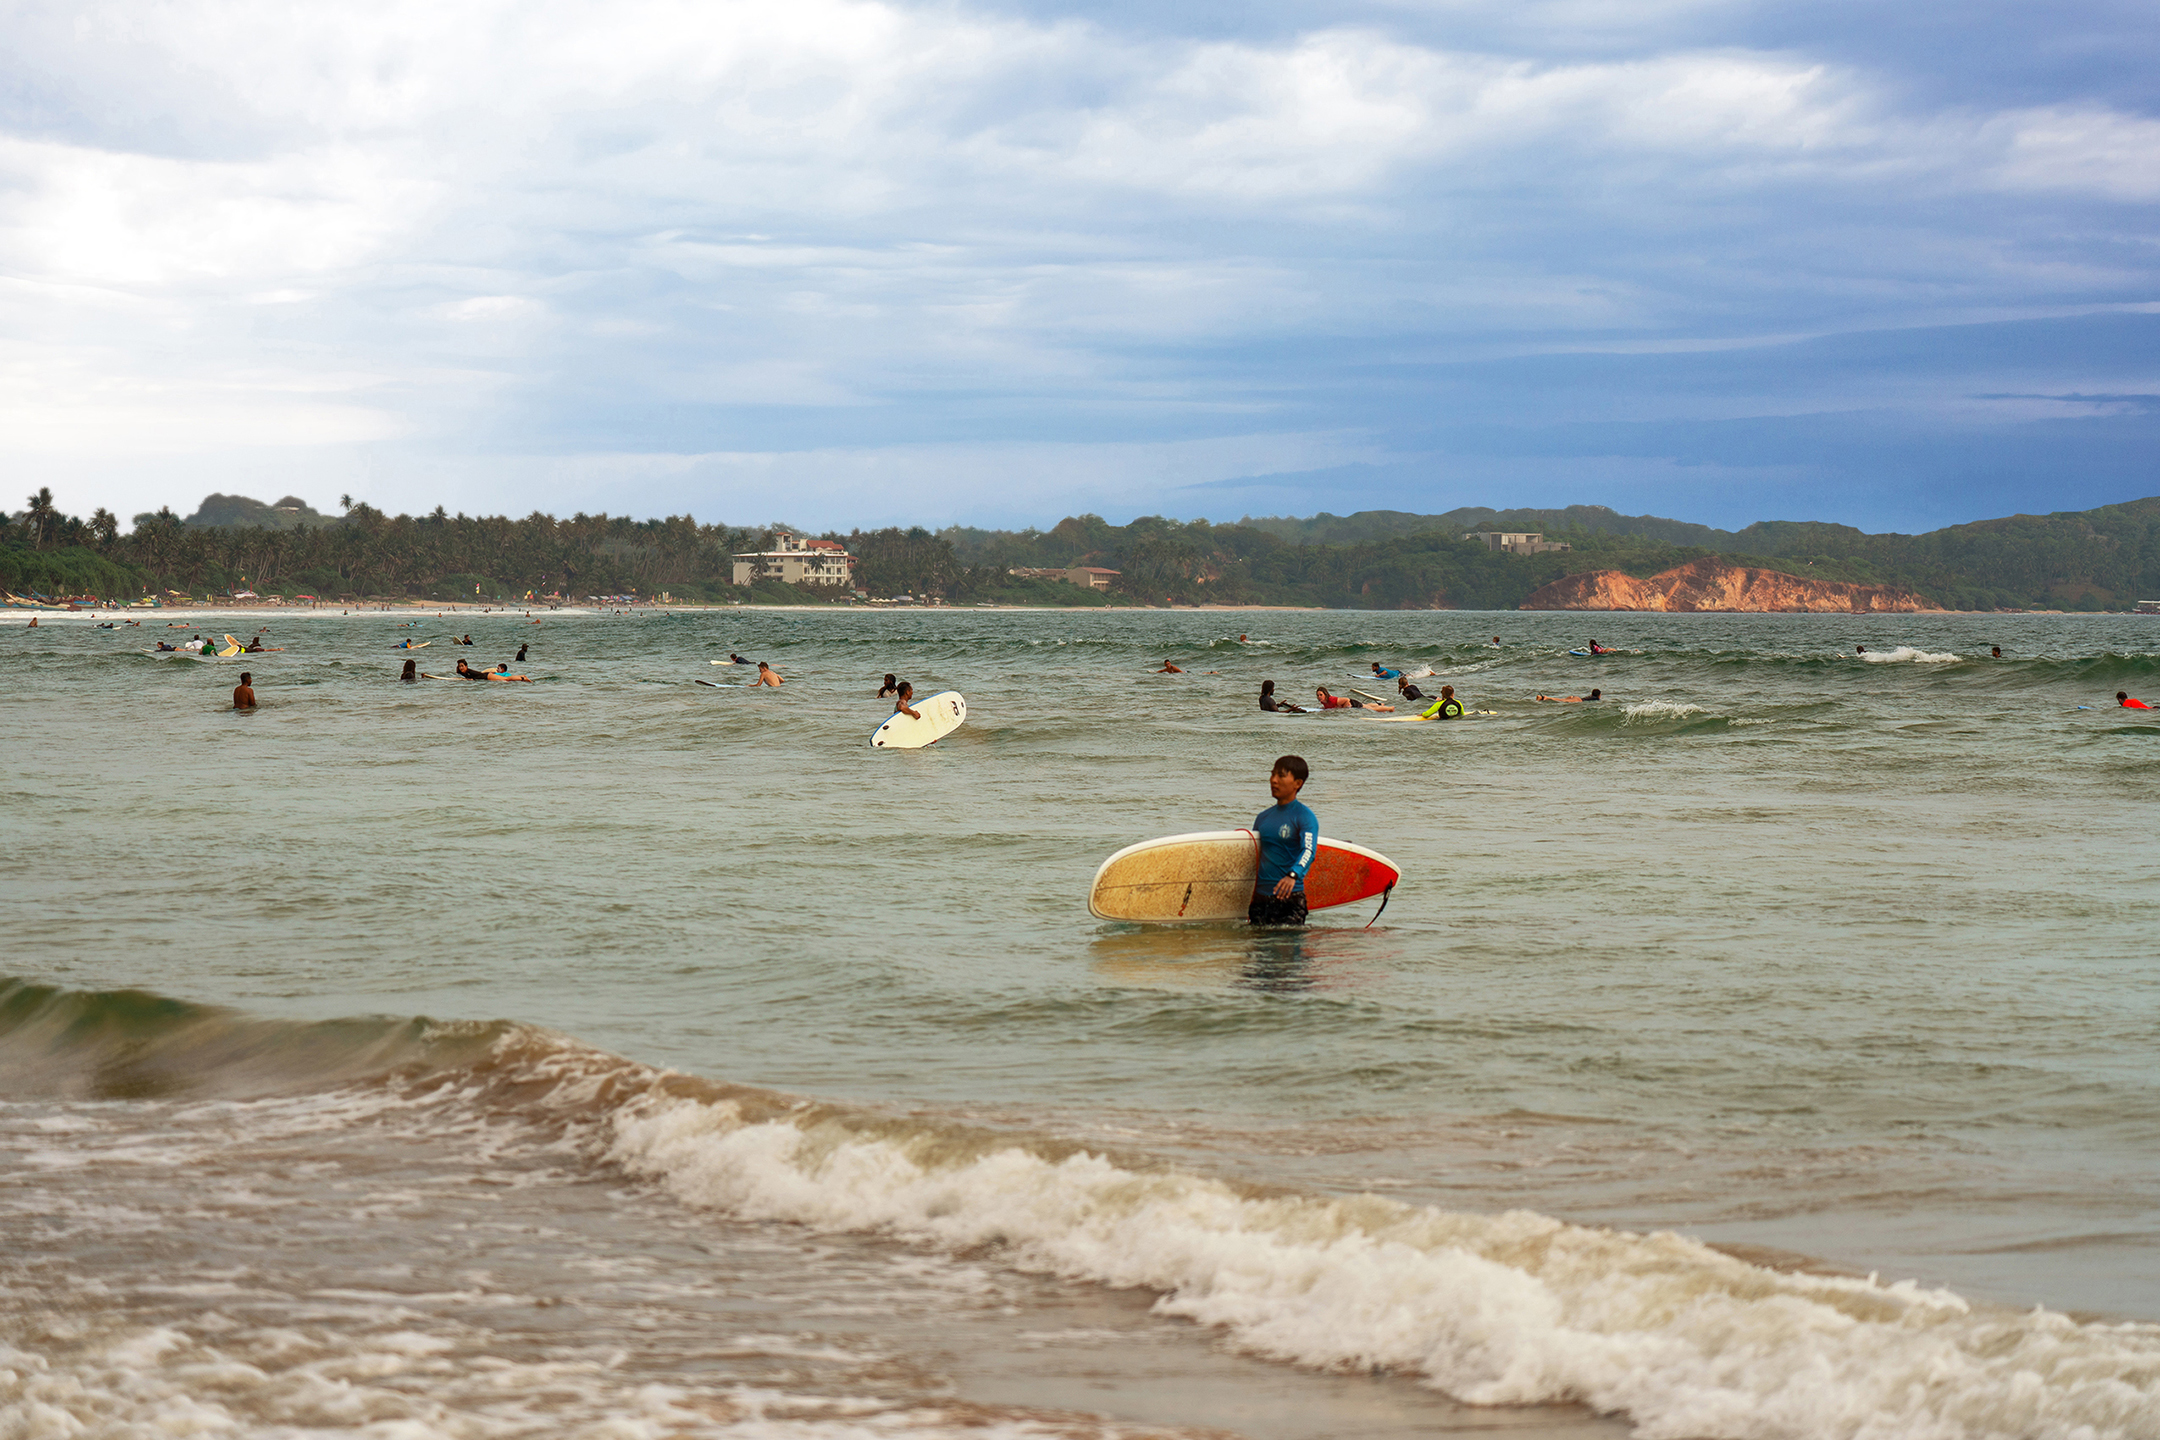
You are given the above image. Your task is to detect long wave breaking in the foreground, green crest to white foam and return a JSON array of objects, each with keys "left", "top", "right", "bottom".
[{"left": 0, "top": 984, "right": 2160, "bottom": 1440}]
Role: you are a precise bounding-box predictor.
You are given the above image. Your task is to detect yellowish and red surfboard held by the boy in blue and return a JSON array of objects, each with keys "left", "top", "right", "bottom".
[{"left": 1086, "top": 829, "right": 1402, "bottom": 924}]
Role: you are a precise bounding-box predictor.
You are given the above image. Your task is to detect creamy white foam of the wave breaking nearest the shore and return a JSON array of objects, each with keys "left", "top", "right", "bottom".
[{"left": 611, "top": 1090, "right": 2160, "bottom": 1440}]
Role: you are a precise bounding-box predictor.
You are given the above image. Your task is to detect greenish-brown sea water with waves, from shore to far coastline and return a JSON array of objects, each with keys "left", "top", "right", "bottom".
[{"left": 0, "top": 609, "right": 2160, "bottom": 1440}]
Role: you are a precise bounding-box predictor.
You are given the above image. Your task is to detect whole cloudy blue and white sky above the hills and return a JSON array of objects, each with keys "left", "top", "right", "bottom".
[{"left": 0, "top": 0, "right": 2160, "bottom": 531}]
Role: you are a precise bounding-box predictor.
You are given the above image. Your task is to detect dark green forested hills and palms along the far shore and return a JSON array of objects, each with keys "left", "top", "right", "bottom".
[{"left": 0, "top": 490, "right": 2160, "bottom": 609}]
